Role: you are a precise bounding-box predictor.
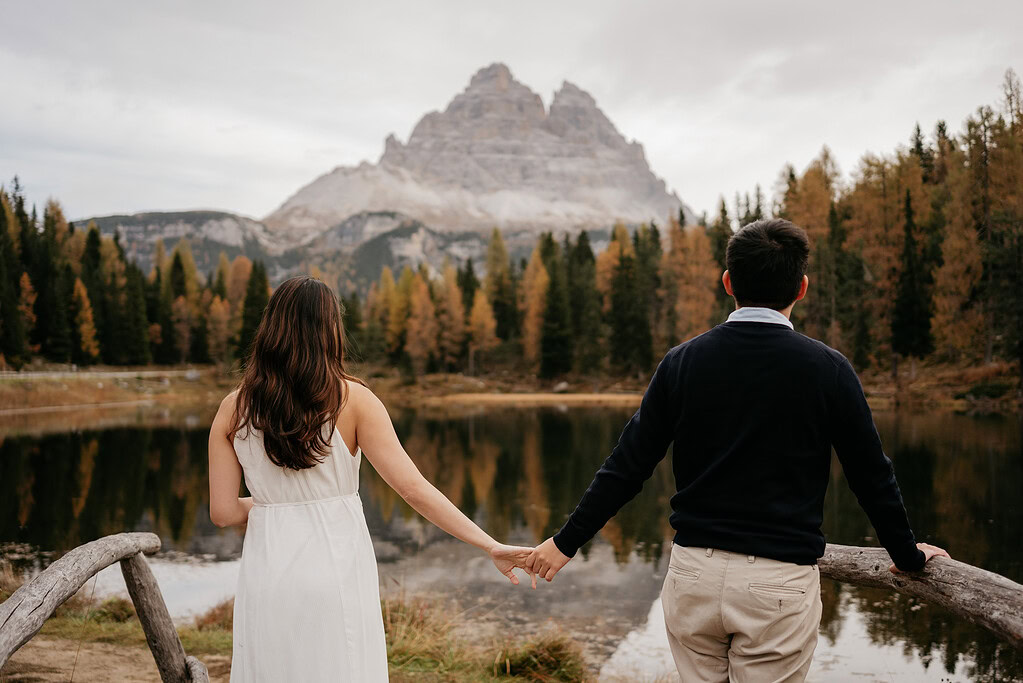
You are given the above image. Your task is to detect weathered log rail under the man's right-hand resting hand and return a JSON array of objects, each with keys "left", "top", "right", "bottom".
[{"left": 817, "top": 543, "right": 1023, "bottom": 647}]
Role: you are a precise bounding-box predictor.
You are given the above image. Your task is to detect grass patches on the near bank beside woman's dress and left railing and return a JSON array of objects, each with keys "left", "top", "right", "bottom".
[{"left": 0, "top": 572, "right": 586, "bottom": 683}]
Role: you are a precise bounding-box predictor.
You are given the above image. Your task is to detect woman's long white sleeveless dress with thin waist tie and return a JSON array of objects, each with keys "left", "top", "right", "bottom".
[{"left": 231, "top": 426, "right": 388, "bottom": 683}]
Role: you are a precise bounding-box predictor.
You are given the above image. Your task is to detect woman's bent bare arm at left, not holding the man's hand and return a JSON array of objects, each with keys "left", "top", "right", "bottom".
[{"left": 210, "top": 393, "right": 253, "bottom": 527}]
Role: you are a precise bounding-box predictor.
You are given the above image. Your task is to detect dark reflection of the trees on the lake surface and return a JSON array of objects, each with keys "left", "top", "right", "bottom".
[{"left": 0, "top": 408, "right": 1023, "bottom": 680}]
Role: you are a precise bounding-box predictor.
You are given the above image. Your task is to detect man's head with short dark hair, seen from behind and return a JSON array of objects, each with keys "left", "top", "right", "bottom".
[{"left": 724, "top": 218, "right": 810, "bottom": 311}]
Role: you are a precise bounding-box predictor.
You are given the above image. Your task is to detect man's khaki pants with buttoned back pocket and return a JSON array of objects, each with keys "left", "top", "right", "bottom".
[{"left": 661, "top": 544, "right": 820, "bottom": 683}]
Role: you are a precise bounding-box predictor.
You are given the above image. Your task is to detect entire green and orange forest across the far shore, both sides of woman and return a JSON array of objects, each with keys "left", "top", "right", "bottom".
[{"left": 0, "top": 70, "right": 1023, "bottom": 386}]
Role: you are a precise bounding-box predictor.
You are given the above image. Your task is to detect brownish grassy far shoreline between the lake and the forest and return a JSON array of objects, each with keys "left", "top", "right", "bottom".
[{"left": 0, "top": 363, "right": 1021, "bottom": 419}]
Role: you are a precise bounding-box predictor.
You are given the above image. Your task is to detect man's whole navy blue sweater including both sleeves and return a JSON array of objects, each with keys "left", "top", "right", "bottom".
[{"left": 554, "top": 321, "right": 924, "bottom": 571}]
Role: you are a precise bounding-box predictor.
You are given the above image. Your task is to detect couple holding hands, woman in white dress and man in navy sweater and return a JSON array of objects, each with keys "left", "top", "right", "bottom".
[{"left": 210, "top": 219, "right": 947, "bottom": 683}]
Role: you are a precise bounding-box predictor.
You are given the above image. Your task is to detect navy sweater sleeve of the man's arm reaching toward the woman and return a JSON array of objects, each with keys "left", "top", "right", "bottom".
[{"left": 554, "top": 354, "right": 677, "bottom": 557}]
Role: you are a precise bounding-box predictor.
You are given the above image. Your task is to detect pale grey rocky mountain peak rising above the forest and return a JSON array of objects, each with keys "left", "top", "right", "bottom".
[{"left": 265, "top": 64, "right": 694, "bottom": 241}]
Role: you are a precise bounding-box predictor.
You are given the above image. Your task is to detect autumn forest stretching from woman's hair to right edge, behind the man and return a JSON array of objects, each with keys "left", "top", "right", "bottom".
[{"left": 348, "top": 70, "right": 1023, "bottom": 386}]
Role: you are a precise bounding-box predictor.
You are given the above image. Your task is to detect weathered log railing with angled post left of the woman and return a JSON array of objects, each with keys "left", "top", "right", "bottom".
[{"left": 0, "top": 533, "right": 210, "bottom": 683}]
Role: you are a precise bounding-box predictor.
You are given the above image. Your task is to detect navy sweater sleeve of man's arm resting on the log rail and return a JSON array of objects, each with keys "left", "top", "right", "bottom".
[{"left": 831, "top": 359, "right": 925, "bottom": 572}]
